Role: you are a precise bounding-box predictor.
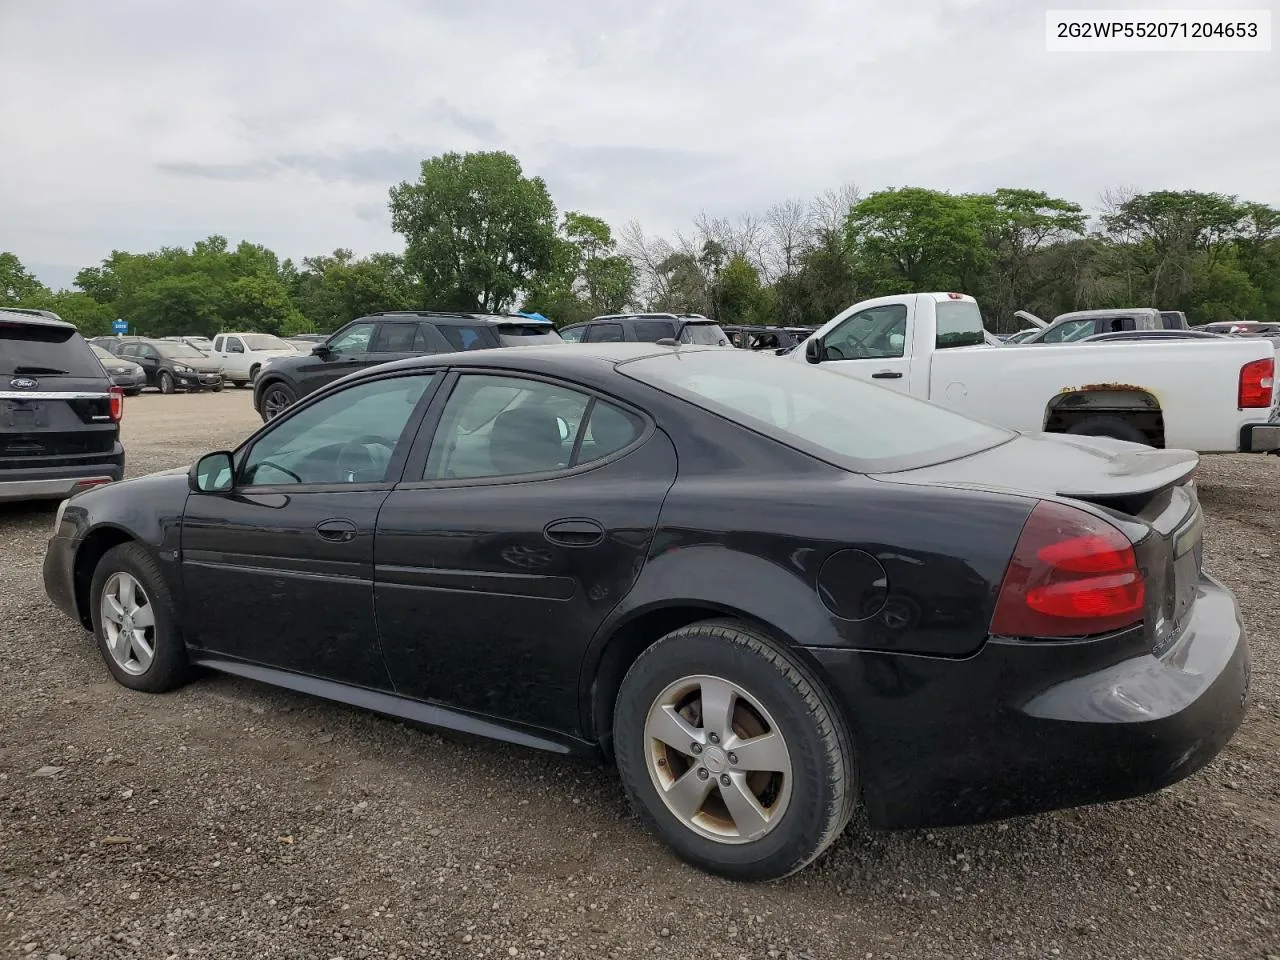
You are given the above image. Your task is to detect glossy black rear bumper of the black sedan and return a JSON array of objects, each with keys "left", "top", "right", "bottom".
[{"left": 810, "top": 570, "right": 1249, "bottom": 828}]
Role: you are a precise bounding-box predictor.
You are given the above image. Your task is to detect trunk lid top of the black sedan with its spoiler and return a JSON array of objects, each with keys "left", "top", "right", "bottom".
[{"left": 876, "top": 434, "right": 1199, "bottom": 500}]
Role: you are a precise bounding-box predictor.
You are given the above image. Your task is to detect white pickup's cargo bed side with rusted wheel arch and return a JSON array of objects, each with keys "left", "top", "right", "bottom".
[{"left": 929, "top": 340, "right": 1275, "bottom": 453}]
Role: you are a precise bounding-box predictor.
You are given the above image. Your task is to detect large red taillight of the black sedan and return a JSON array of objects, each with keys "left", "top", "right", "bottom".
[{"left": 991, "top": 500, "right": 1147, "bottom": 637}]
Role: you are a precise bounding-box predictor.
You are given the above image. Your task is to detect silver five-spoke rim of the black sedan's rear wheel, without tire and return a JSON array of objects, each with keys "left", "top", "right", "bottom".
[{"left": 644, "top": 676, "right": 792, "bottom": 844}]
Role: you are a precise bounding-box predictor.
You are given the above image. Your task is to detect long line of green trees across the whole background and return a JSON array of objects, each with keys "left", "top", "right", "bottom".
[{"left": 0, "top": 152, "right": 1280, "bottom": 337}]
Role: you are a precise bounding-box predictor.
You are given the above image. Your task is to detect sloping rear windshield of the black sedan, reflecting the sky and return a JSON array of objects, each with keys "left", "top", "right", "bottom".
[{"left": 618, "top": 351, "right": 1014, "bottom": 474}]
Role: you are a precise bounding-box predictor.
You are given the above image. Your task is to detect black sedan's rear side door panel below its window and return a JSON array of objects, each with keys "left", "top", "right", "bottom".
[{"left": 374, "top": 433, "right": 676, "bottom": 732}]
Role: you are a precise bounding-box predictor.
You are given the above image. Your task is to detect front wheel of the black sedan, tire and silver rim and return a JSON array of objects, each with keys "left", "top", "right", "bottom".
[{"left": 90, "top": 543, "right": 191, "bottom": 694}]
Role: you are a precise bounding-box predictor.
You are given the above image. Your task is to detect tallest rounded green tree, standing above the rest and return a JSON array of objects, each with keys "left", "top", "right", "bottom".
[{"left": 390, "top": 152, "right": 557, "bottom": 312}]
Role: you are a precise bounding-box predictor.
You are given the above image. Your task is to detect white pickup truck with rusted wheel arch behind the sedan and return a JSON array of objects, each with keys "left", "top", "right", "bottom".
[{"left": 780, "top": 293, "right": 1280, "bottom": 453}]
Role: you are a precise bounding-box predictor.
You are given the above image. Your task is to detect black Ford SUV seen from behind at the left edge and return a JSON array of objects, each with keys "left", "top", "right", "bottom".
[{"left": 0, "top": 307, "right": 124, "bottom": 500}]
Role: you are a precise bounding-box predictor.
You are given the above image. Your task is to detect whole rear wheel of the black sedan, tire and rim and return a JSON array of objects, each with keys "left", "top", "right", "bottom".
[{"left": 613, "top": 621, "right": 855, "bottom": 879}]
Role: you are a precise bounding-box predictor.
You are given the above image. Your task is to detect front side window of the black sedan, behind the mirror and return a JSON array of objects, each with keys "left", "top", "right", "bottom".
[{"left": 241, "top": 374, "right": 434, "bottom": 486}]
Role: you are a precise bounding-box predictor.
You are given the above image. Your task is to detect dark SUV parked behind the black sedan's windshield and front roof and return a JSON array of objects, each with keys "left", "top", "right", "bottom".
[{"left": 253, "top": 310, "right": 561, "bottom": 421}]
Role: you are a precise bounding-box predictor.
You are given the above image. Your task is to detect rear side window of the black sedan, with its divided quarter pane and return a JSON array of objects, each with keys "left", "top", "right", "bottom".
[{"left": 422, "top": 374, "right": 643, "bottom": 480}]
